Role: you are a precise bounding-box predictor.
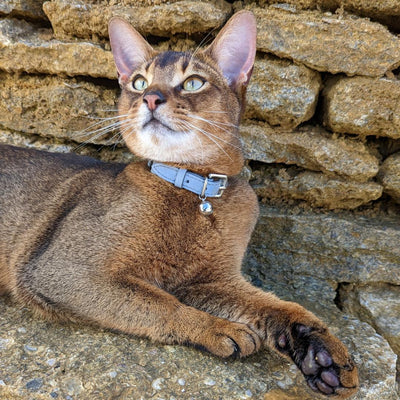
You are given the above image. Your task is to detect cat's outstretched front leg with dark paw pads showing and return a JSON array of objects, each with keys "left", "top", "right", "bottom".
[{"left": 178, "top": 278, "right": 358, "bottom": 399}]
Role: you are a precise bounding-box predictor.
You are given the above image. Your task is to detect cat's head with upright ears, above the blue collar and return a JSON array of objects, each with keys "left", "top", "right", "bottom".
[{"left": 109, "top": 11, "right": 256, "bottom": 175}]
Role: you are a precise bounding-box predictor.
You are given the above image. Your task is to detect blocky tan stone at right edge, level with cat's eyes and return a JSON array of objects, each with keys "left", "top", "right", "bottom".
[{"left": 324, "top": 77, "right": 400, "bottom": 139}]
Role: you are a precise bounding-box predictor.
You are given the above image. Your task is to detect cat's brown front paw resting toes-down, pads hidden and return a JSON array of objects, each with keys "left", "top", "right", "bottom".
[{"left": 200, "top": 318, "right": 261, "bottom": 358}]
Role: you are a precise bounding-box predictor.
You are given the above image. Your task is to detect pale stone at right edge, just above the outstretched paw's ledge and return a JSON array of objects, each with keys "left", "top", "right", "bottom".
[{"left": 339, "top": 284, "right": 400, "bottom": 355}]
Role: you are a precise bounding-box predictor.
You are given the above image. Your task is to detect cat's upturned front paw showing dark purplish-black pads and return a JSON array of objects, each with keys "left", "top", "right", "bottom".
[{"left": 276, "top": 324, "right": 358, "bottom": 399}]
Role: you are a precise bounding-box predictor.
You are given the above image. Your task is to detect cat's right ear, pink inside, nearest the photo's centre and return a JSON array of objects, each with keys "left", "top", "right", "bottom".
[{"left": 205, "top": 10, "right": 257, "bottom": 88}]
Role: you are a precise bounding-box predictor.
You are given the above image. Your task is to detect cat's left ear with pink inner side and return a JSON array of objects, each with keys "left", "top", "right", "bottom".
[{"left": 108, "top": 17, "right": 155, "bottom": 83}]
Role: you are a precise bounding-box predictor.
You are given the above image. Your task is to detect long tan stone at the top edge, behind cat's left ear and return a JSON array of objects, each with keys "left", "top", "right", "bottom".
[{"left": 43, "top": 0, "right": 231, "bottom": 38}]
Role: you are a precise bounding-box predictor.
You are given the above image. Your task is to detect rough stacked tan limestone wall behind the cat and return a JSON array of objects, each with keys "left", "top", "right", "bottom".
[{"left": 0, "top": 0, "right": 400, "bottom": 399}]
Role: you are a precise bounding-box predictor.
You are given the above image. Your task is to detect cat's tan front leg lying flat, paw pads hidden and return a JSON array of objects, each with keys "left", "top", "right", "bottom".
[{"left": 30, "top": 276, "right": 261, "bottom": 357}]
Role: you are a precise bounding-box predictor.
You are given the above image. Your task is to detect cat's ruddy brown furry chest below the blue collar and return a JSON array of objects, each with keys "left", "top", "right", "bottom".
[{"left": 112, "top": 163, "right": 257, "bottom": 287}]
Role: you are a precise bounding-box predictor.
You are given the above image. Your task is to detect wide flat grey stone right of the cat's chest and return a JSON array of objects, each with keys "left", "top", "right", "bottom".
[{"left": 250, "top": 206, "right": 400, "bottom": 285}]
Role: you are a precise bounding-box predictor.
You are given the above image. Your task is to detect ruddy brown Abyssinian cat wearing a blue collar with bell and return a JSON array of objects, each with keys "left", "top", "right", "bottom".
[{"left": 0, "top": 11, "right": 358, "bottom": 399}]
